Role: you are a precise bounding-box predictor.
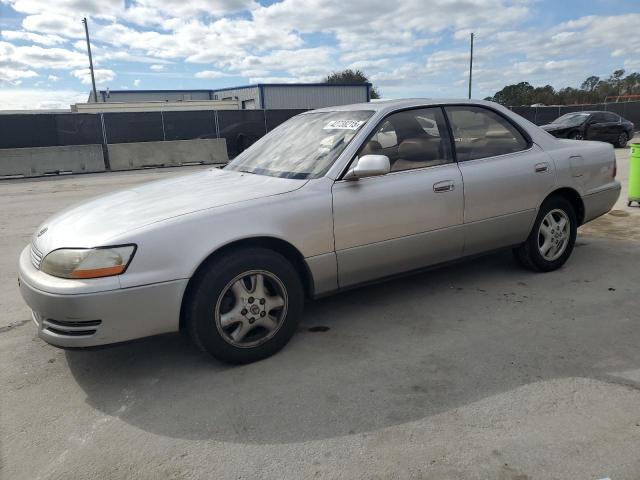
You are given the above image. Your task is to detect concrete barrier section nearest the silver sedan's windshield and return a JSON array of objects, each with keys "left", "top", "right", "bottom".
[{"left": 108, "top": 138, "right": 229, "bottom": 170}]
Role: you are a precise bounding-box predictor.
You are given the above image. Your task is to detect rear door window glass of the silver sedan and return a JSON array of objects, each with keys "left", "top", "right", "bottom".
[{"left": 445, "top": 106, "right": 529, "bottom": 162}]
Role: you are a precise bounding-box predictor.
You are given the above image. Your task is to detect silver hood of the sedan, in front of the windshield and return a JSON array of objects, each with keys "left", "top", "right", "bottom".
[{"left": 33, "top": 168, "right": 306, "bottom": 254}]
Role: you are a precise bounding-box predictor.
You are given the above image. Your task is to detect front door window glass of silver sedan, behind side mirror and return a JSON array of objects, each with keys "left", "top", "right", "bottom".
[{"left": 358, "top": 107, "right": 453, "bottom": 172}]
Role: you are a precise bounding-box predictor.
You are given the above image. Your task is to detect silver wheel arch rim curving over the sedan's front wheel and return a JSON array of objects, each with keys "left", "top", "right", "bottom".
[{"left": 180, "top": 236, "right": 314, "bottom": 330}]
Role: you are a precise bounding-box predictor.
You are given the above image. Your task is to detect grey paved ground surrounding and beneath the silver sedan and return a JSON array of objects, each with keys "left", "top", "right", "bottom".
[{"left": 0, "top": 145, "right": 640, "bottom": 480}]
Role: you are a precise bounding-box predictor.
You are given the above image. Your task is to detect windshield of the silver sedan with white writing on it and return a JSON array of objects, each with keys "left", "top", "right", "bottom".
[{"left": 225, "top": 110, "right": 373, "bottom": 179}]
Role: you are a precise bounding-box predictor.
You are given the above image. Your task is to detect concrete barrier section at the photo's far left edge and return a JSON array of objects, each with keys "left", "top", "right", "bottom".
[{"left": 0, "top": 145, "right": 105, "bottom": 177}]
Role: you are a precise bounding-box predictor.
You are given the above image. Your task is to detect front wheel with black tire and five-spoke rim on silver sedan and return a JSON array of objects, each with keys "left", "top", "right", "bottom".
[{"left": 184, "top": 248, "right": 304, "bottom": 364}]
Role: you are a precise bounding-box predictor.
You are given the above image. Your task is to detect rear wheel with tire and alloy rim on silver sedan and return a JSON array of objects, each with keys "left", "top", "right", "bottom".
[{"left": 513, "top": 196, "right": 578, "bottom": 272}]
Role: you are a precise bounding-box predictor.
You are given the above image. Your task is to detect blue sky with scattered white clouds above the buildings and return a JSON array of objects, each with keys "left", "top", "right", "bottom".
[{"left": 0, "top": 0, "right": 640, "bottom": 109}]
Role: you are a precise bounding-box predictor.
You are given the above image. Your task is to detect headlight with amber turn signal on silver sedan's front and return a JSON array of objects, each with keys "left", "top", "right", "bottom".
[{"left": 40, "top": 245, "right": 136, "bottom": 278}]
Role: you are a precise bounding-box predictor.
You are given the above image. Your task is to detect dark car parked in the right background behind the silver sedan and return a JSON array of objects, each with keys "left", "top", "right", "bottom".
[{"left": 541, "top": 112, "right": 635, "bottom": 148}]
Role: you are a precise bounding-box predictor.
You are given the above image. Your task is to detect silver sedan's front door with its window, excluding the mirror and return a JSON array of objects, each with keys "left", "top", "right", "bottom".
[{"left": 333, "top": 107, "right": 464, "bottom": 287}]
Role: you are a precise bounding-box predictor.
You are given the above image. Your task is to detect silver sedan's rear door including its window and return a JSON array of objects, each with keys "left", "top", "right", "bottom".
[{"left": 445, "top": 105, "right": 555, "bottom": 255}]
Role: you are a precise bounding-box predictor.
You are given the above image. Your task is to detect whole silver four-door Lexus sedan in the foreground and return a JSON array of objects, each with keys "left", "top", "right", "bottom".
[{"left": 19, "top": 99, "right": 620, "bottom": 363}]
